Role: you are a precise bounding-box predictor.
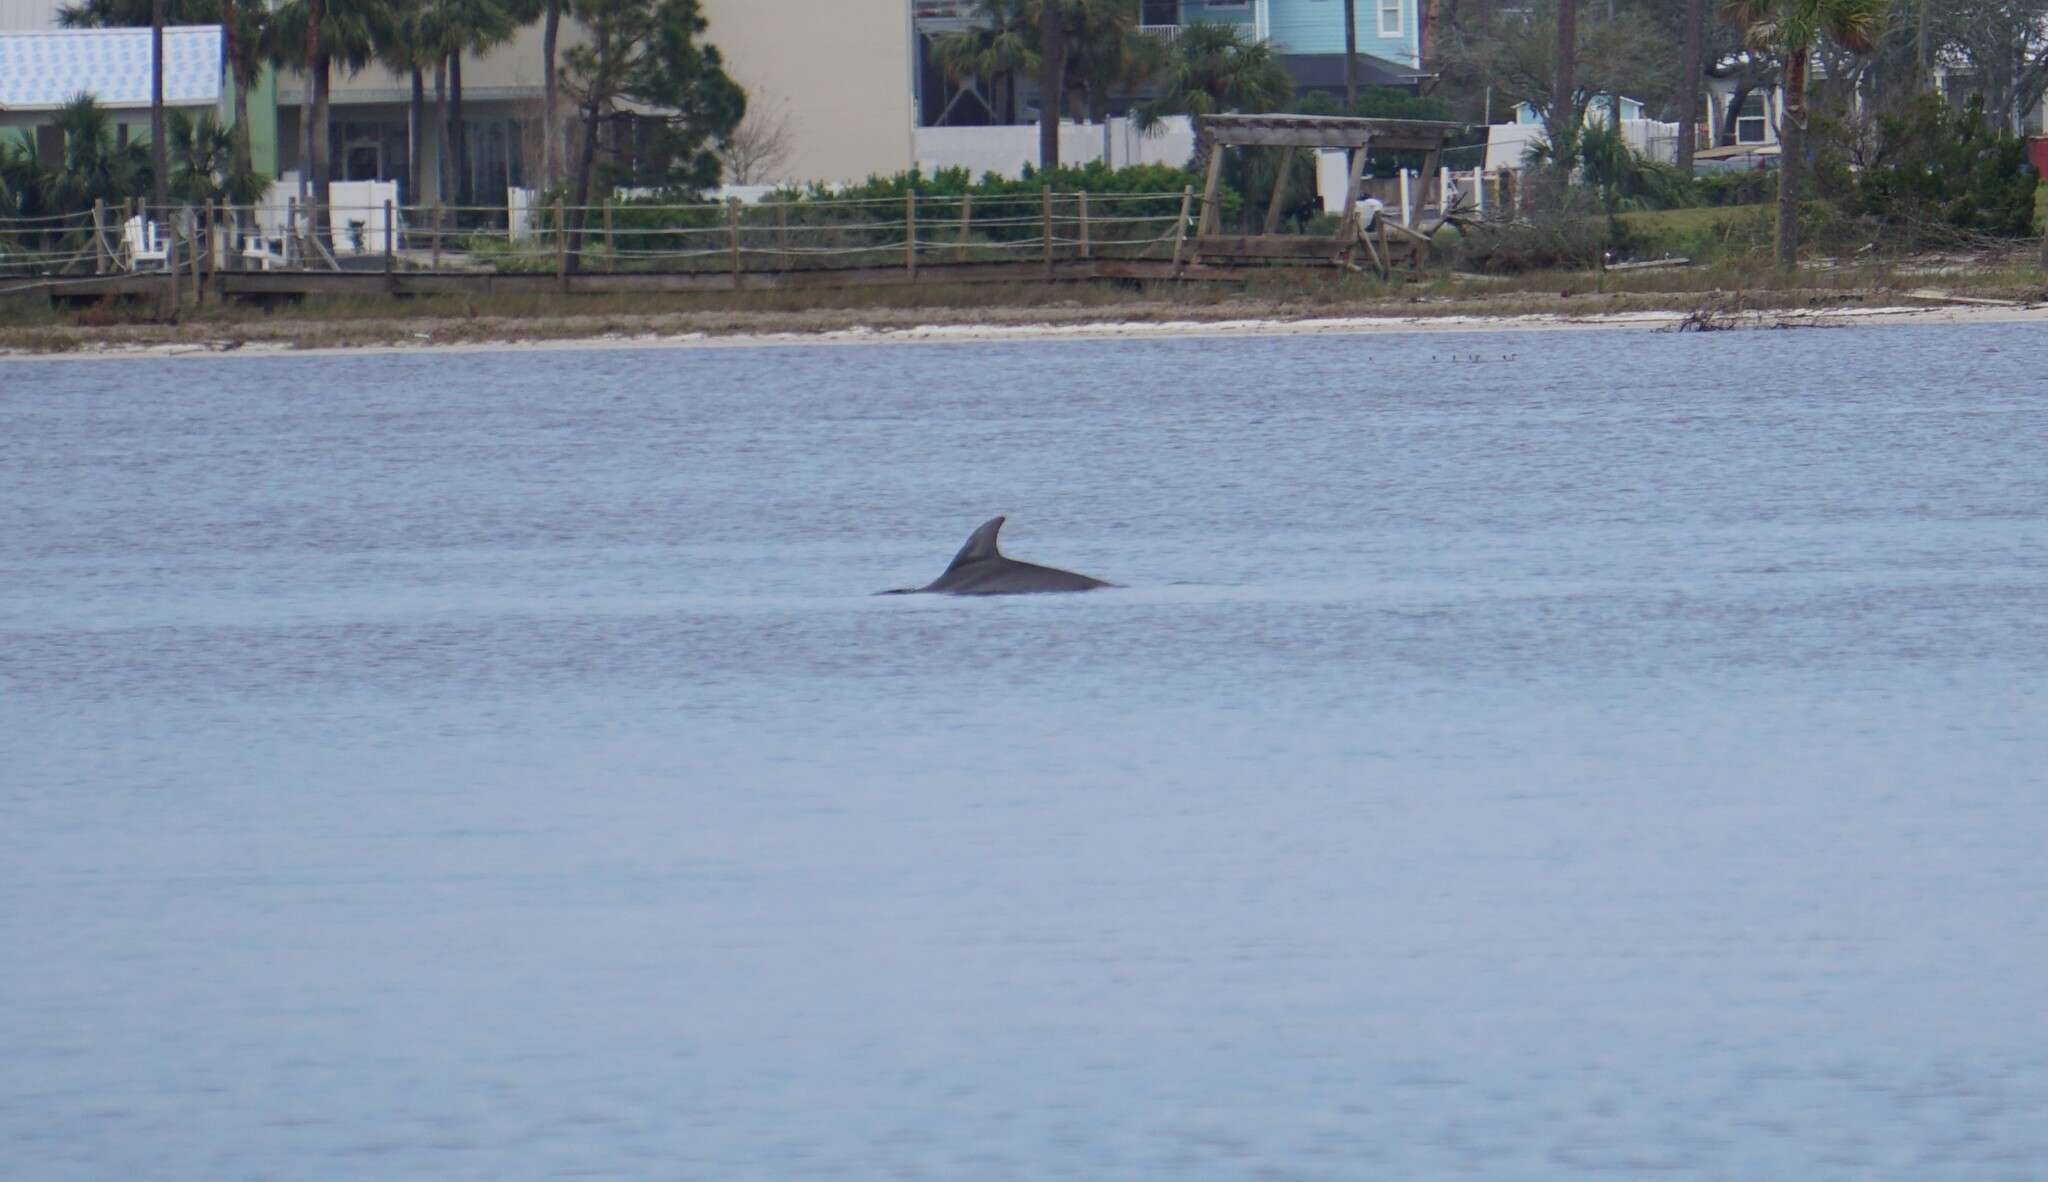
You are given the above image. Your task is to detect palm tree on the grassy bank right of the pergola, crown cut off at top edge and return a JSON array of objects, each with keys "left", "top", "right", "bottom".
[{"left": 1729, "top": 0, "right": 1890, "bottom": 268}]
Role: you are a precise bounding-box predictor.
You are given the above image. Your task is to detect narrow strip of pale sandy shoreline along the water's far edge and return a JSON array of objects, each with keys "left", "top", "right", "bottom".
[{"left": 0, "top": 297, "right": 2048, "bottom": 363}]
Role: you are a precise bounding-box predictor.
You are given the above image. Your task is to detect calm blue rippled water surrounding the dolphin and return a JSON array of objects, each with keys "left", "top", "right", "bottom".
[{"left": 0, "top": 326, "right": 2048, "bottom": 1182}]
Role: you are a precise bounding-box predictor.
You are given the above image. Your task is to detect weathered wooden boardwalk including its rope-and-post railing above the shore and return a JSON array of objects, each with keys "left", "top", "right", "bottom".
[{"left": 0, "top": 186, "right": 1243, "bottom": 309}]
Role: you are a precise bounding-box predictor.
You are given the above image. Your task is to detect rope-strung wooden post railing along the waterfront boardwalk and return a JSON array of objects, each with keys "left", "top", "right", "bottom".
[{"left": 0, "top": 188, "right": 1196, "bottom": 291}]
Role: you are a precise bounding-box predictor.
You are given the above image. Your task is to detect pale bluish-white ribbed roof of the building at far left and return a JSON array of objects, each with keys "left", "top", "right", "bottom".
[{"left": 0, "top": 25, "right": 221, "bottom": 111}]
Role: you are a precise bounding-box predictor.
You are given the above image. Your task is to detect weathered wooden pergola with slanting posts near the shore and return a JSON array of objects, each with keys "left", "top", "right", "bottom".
[{"left": 1190, "top": 115, "right": 1460, "bottom": 275}]
